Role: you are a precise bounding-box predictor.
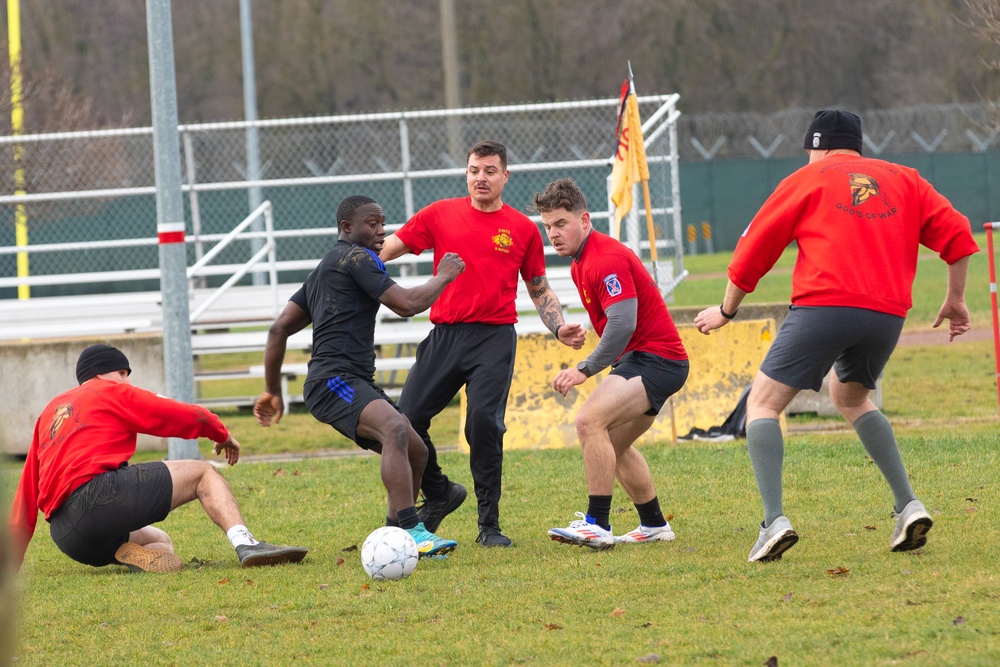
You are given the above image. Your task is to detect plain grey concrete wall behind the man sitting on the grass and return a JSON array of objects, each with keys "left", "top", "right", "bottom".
[{"left": 0, "top": 334, "right": 167, "bottom": 454}]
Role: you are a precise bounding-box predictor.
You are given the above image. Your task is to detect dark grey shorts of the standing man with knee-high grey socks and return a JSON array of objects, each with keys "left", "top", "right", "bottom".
[{"left": 760, "top": 306, "right": 904, "bottom": 391}]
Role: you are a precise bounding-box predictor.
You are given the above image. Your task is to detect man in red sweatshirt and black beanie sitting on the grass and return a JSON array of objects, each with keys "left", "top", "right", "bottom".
[{"left": 9, "top": 345, "right": 309, "bottom": 572}]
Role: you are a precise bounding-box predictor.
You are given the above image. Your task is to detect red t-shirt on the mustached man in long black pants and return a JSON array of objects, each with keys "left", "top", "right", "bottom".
[{"left": 396, "top": 197, "right": 545, "bottom": 324}]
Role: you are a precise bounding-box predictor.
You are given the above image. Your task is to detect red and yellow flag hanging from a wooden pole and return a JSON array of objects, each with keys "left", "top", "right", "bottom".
[{"left": 610, "top": 75, "right": 649, "bottom": 238}]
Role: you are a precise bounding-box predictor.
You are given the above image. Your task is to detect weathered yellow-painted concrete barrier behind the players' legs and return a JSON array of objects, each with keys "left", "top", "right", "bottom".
[{"left": 458, "top": 318, "right": 777, "bottom": 452}]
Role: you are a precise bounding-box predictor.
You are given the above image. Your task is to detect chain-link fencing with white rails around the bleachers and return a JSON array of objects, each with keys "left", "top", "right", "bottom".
[{"left": 0, "top": 95, "right": 679, "bottom": 297}]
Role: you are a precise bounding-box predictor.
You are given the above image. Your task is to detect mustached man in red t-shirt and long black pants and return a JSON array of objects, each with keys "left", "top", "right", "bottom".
[{"left": 379, "top": 141, "right": 584, "bottom": 547}]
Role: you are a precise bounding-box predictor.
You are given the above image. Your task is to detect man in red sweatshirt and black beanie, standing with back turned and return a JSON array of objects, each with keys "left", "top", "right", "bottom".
[{"left": 695, "top": 110, "right": 979, "bottom": 562}]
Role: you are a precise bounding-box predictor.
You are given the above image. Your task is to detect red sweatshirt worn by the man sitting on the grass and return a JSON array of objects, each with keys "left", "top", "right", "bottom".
[{"left": 9, "top": 378, "right": 229, "bottom": 567}]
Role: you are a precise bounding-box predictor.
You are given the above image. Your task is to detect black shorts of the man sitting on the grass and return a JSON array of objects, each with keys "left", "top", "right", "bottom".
[{"left": 49, "top": 461, "right": 174, "bottom": 567}]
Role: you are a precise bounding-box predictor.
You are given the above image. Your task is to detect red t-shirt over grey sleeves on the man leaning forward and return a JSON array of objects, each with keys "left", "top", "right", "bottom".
[{"left": 570, "top": 230, "right": 688, "bottom": 361}]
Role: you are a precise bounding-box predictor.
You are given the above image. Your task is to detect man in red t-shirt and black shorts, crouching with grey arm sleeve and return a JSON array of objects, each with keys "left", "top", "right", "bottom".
[{"left": 534, "top": 178, "right": 689, "bottom": 550}]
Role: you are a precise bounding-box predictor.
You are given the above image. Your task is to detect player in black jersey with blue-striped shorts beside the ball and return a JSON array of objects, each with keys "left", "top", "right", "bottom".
[{"left": 254, "top": 195, "right": 465, "bottom": 557}]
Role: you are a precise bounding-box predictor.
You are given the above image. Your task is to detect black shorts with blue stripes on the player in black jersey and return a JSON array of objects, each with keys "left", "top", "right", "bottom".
[{"left": 302, "top": 373, "right": 399, "bottom": 451}]
